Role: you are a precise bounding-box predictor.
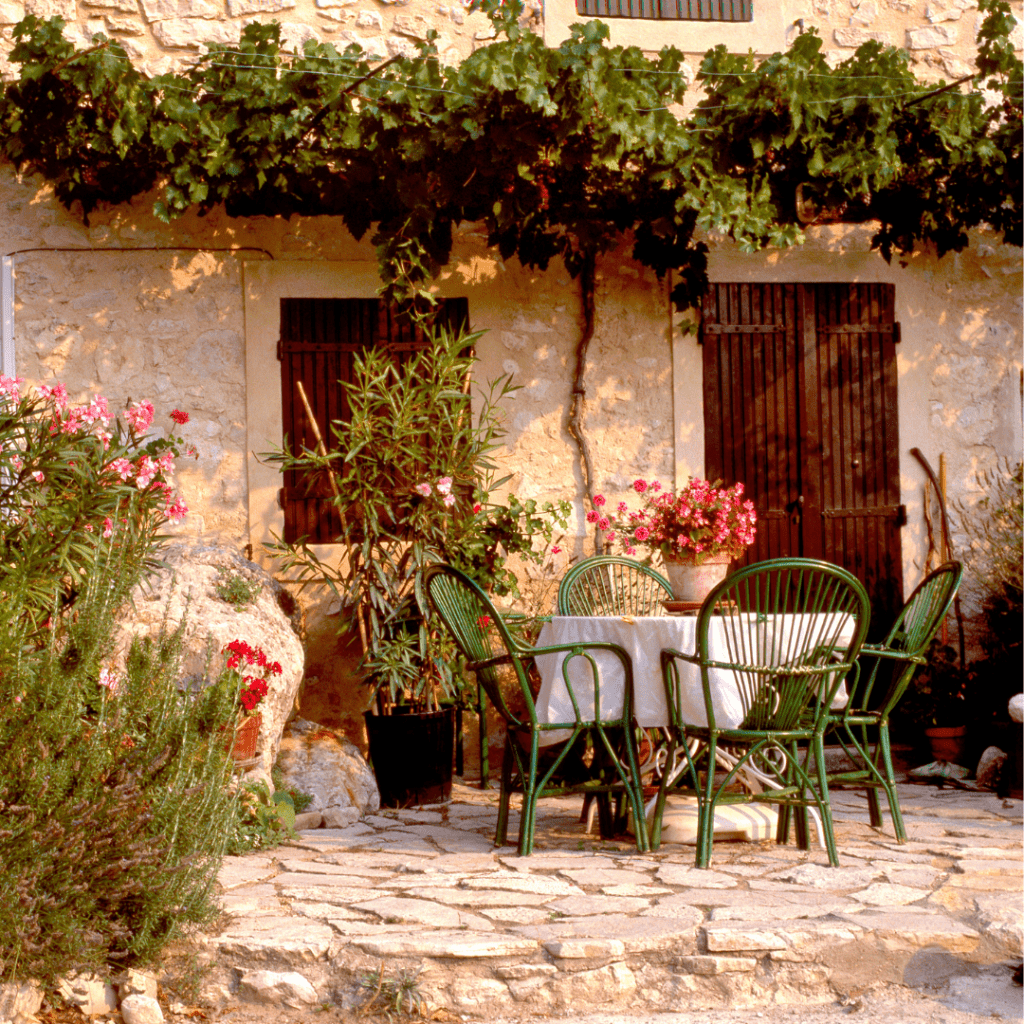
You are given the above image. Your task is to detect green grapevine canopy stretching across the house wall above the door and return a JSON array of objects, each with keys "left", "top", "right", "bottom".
[{"left": 0, "top": 0, "right": 1024, "bottom": 306}]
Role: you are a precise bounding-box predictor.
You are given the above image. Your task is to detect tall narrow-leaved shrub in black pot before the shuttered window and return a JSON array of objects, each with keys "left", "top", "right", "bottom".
[{"left": 269, "top": 328, "right": 568, "bottom": 806}]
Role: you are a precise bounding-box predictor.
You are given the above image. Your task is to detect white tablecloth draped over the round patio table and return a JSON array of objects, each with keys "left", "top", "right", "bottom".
[{"left": 537, "top": 615, "right": 854, "bottom": 741}]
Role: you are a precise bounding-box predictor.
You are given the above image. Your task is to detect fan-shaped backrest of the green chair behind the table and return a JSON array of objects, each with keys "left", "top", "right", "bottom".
[{"left": 558, "top": 555, "right": 672, "bottom": 615}]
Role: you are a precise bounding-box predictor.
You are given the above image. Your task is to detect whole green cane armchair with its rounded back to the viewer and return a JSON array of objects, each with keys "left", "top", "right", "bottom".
[{"left": 650, "top": 558, "right": 870, "bottom": 867}]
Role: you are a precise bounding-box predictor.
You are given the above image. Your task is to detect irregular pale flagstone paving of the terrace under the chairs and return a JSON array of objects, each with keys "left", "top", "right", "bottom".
[{"left": 195, "top": 785, "right": 1024, "bottom": 1019}]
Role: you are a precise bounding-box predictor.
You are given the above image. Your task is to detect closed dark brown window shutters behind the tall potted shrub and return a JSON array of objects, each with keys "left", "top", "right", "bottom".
[{"left": 278, "top": 298, "right": 469, "bottom": 544}]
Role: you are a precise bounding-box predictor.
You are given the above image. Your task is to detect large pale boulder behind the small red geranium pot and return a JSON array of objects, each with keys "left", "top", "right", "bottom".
[{"left": 119, "top": 540, "right": 305, "bottom": 779}]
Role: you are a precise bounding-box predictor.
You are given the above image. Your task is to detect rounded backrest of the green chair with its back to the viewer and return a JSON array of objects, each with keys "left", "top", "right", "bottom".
[{"left": 696, "top": 558, "right": 870, "bottom": 732}]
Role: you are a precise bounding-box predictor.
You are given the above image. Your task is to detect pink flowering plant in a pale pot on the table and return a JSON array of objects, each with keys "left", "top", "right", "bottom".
[{"left": 587, "top": 478, "right": 757, "bottom": 603}]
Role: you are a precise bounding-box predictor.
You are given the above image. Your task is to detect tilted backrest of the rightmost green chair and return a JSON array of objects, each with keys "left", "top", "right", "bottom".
[{"left": 851, "top": 561, "right": 964, "bottom": 717}]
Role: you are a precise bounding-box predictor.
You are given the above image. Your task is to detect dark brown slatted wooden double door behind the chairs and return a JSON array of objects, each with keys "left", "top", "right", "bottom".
[{"left": 701, "top": 284, "right": 905, "bottom": 635}]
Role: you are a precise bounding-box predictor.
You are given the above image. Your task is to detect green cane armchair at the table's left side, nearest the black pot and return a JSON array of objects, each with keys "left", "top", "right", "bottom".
[{"left": 422, "top": 564, "right": 647, "bottom": 856}]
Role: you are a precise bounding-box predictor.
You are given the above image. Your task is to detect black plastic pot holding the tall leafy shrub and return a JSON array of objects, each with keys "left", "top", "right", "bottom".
[{"left": 366, "top": 708, "right": 455, "bottom": 807}]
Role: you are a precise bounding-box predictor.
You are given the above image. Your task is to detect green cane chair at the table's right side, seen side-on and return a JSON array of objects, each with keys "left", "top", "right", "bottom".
[{"left": 811, "top": 562, "right": 964, "bottom": 843}]
